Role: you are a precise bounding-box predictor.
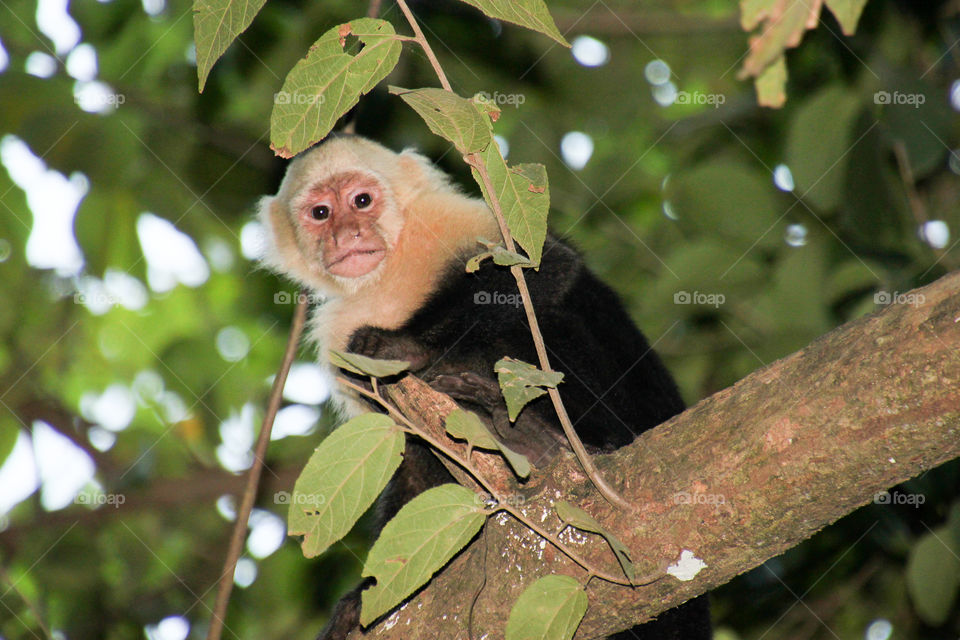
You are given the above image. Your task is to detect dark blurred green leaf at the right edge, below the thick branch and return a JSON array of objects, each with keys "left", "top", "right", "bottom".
[{"left": 907, "top": 527, "right": 960, "bottom": 627}]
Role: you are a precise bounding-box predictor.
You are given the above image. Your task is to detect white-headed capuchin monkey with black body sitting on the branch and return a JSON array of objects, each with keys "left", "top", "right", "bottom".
[{"left": 259, "top": 136, "right": 711, "bottom": 640}]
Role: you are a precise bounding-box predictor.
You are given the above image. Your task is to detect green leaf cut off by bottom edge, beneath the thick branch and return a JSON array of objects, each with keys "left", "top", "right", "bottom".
[{"left": 506, "top": 575, "right": 587, "bottom": 640}]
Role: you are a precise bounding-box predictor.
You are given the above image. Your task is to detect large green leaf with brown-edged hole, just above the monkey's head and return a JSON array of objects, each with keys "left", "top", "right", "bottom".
[{"left": 270, "top": 18, "right": 401, "bottom": 158}]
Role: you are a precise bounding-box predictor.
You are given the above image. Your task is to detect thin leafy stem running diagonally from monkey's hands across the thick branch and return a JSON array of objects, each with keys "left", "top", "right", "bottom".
[{"left": 337, "top": 376, "right": 636, "bottom": 586}]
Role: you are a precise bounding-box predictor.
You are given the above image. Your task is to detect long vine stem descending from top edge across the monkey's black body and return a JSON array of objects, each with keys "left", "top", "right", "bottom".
[{"left": 397, "top": 0, "right": 636, "bottom": 511}]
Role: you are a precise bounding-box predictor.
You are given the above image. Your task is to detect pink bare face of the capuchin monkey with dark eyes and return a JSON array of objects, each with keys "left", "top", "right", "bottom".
[{"left": 299, "top": 173, "right": 387, "bottom": 278}]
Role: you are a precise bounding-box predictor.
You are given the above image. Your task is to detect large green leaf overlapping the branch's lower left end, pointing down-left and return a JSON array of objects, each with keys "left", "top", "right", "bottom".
[{"left": 360, "top": 484, "right": 487, "bottom": 626}]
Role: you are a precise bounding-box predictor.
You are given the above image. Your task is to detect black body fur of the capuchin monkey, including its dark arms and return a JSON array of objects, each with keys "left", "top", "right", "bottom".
[{"left": 320, "top": 237, "right": 711, "bottom": 640}]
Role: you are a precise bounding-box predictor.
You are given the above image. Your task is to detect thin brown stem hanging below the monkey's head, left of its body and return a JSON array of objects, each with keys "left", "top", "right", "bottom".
[{"left": 207, "top": 291, "right": 307, "bottom": 640}]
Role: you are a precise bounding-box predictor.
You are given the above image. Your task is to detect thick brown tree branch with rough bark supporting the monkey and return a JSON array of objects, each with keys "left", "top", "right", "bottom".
[{"left": 357, "top": 273, "right": 960, "bottom": 639}]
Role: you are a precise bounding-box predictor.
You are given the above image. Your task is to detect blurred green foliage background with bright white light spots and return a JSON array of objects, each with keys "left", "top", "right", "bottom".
[{"left": 0, "top": 0, "right": 960, "bottom": 640}]
